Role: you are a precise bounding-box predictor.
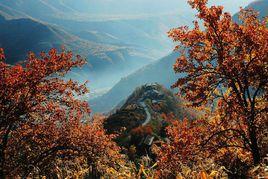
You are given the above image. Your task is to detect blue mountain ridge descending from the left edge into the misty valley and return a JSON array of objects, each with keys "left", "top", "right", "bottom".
[{"left": 0, "top": 13, "right": 152, "bottom": 88}]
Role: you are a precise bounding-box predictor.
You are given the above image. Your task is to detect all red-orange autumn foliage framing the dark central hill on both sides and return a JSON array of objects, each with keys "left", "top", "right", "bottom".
[{"left": 0, "top": 0, "right": 268, "bottom": 178}]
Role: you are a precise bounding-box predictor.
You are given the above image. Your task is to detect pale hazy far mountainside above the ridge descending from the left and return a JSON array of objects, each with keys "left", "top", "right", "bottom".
[{"left": 0, "top": 0, "right": 252, "bottom": 57}]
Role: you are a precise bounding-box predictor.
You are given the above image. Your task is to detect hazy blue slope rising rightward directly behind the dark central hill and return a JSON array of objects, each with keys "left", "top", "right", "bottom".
[{"left": 89, "top": 53, "right": 178, "bottom": 112}]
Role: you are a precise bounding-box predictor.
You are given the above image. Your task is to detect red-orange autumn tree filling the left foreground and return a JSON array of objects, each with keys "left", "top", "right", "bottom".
[{"left": 0, "top": 49, "right": 123, "bottom": 178}]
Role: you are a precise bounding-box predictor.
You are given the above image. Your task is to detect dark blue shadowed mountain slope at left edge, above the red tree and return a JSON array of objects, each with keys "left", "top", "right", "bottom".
[{"left": 0, "top": 15, "right": 66, "bottom": 63}]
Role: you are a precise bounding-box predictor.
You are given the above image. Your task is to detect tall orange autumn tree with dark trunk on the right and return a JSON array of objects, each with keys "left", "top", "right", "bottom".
[{"left": 156, "top": 0, "right": 268, "bottom": 176}]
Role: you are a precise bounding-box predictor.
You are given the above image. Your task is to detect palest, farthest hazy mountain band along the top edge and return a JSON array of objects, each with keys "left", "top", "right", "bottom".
[{"left": 0, "top": 0, "right": 252, "bottom": 18}]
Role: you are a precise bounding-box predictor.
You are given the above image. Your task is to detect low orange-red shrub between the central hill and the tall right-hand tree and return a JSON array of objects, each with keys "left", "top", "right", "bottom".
[{"left": 153, "top": 116, "right": 226, "bottom": 178}]
